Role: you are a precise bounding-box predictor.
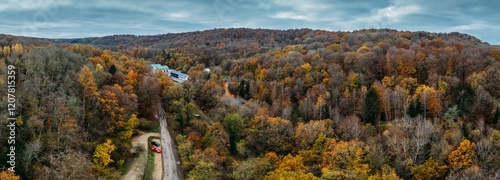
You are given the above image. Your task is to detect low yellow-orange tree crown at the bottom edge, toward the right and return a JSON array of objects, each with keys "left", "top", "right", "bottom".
[{"left": 411, "top": 158, "right": 448, "bottom": 180}]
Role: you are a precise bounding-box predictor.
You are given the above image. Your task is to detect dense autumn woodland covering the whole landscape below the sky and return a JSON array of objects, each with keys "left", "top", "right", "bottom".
[{"left": 0, "top": 29, "right": 500, "bottom": 180}]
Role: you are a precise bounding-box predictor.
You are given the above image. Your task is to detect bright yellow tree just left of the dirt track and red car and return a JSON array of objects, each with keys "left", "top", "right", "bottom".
[{"left": 92, "top": 139, "right": 116, "bottom": 175}]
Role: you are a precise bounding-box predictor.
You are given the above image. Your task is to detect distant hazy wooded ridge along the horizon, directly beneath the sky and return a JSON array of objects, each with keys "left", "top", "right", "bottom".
[{"left": 0, "top": 28, "right": 489, "bottom": 50}]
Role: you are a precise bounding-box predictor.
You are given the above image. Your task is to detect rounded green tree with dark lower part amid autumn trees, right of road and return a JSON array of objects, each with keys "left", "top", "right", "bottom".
[{"left": 223, "top": 113, "right": 245, "bottom": 155}]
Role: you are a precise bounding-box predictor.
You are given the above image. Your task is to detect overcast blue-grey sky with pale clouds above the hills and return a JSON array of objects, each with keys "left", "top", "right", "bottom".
[{"left": 0, "top": 0, "right": 500, "bottom": 44}]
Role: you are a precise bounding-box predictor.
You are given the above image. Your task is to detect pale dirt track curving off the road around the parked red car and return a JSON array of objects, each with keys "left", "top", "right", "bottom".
[{"left": 122, "top": 133, "right": 162, "bottom": 180}]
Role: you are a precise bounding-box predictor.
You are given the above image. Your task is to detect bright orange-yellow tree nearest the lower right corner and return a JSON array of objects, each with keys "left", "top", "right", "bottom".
[{"left": 448, "top": 139, "right": 476, "bottom": 170}]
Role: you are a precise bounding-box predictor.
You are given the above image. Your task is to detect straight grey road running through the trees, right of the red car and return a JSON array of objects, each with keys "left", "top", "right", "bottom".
[{"left": 157, "top": 104, "right": 183, "bottom": 180}]
